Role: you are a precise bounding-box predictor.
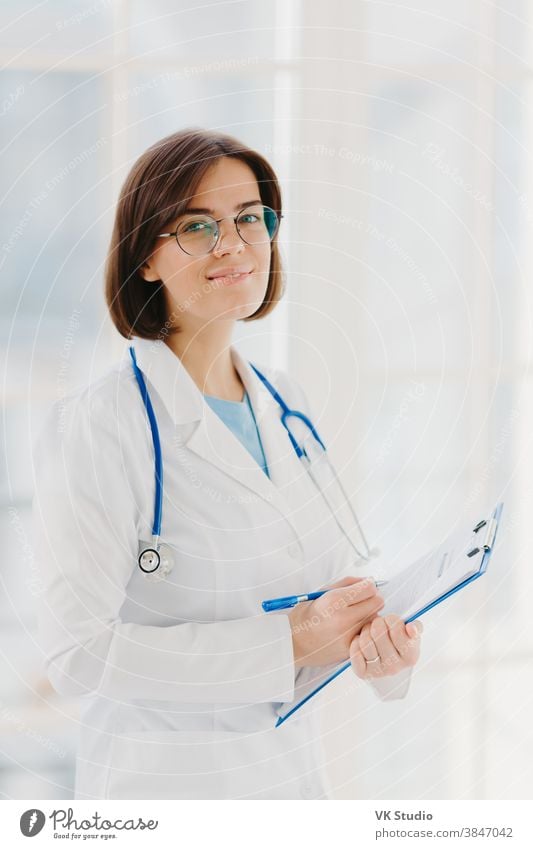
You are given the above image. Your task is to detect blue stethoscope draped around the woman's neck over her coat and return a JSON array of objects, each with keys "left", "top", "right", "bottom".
[{"left": 129, "top": 347, "right": 379, "bottom": 580}]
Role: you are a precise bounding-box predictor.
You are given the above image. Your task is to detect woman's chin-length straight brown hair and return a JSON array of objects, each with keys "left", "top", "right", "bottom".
[{"left": 105, "top": 127, "right": 284, "bottom": 339}]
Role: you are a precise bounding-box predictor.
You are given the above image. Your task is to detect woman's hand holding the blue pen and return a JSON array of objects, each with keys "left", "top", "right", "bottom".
[{"left": 287, "top": 577, "right": 384, "bottom": 668}]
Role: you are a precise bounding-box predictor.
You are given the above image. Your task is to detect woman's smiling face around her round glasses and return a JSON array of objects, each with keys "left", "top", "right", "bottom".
[{"left": 140, "top": 157, "right": 270, "bottom": 330}]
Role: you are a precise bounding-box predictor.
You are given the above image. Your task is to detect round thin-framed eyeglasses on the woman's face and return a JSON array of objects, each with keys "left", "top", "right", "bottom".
[{"left": 156, "top": 203, "right": 283, "bottom": 256}]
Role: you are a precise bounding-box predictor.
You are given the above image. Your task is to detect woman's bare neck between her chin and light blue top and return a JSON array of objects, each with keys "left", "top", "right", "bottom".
[{"left": 165, "top": 321, "right": 244, "bottom": 401}]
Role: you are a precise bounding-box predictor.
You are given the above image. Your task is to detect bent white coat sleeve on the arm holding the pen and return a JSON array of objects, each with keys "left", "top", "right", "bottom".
[{"left": 33, "top": 395, "right": 294, "bottom": 704}]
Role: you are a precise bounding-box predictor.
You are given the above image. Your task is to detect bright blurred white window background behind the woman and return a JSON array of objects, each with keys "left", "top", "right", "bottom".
[{"left": 0, "top": 0, "right": 533, "bottom": 799}]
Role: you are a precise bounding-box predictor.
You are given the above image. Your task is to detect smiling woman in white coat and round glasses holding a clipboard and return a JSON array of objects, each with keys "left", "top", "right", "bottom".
[{"left": 35, "top": 129, "right": 419, "bottom": 799}]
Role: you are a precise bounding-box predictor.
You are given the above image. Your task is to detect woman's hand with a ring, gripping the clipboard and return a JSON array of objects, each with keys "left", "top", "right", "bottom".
[{"left": 350, "top": 614, "right": 424, "bottom": 679}]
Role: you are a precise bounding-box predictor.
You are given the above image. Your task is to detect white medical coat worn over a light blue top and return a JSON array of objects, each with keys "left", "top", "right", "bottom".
[{"left": 34, "top": 339, "right": 409, "bottom": 799}]
